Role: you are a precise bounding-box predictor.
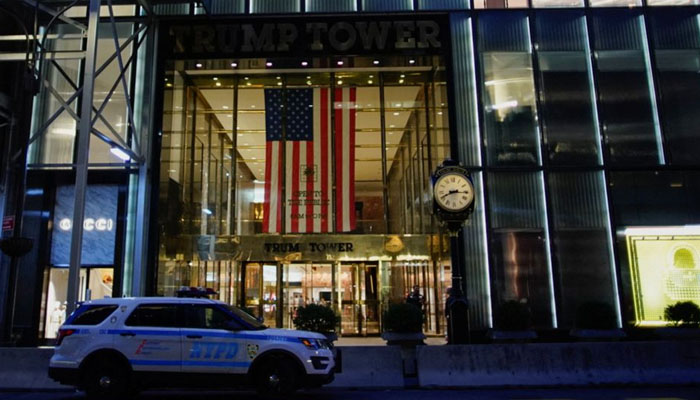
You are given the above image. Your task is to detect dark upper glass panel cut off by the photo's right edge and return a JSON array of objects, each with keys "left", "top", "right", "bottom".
[{"left": 651, "top": 9, "right": 700, "bottom": 164}]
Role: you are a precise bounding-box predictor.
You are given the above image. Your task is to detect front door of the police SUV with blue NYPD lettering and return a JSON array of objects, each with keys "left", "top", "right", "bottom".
[{"left": 182, "top": 303, "right": 250, "bottom": 373}]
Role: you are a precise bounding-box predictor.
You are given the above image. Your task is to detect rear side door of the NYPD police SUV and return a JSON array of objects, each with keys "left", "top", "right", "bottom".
[{"left": 119, "top": 303, "right": 182, "bottom": 372}]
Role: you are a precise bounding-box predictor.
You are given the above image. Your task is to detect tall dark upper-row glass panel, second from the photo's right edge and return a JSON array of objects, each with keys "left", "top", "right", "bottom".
[{"left": 591, "top": 10, "right": 663, "bottom": 164}]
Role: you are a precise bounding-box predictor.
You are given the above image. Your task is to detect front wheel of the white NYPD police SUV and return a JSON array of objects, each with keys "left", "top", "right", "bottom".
[{"left": 255, "top": 357, "right": 300, "bottom": 395}]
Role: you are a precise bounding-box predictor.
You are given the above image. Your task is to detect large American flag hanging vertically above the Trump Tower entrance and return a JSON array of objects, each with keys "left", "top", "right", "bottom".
[{"left": 263, "top": 88, "right": 356, "bottom": 233}]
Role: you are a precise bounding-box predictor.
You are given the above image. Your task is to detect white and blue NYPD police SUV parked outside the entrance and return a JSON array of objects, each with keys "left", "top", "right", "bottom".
[{"left": 49, "top": 290, "right": 335, "bottom": 398}]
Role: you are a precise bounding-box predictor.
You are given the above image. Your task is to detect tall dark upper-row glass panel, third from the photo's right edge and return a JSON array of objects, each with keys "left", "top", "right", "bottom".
[{"left": 535, "top": 11, "right": 600, "bottom": 165}]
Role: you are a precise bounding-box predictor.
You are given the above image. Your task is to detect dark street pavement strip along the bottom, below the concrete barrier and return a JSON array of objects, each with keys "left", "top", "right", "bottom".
[{"left": 0, "top": 387, "right": 700, "bottom": 400}]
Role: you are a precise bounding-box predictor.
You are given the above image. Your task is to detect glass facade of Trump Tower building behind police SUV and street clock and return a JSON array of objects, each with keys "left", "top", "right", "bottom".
[{"left": 4, "top": 0, "right": 700, "bottom": 344}]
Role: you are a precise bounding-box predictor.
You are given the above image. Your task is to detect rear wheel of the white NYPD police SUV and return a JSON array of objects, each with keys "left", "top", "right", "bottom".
[{"left": 83, "top": 360, "right": 129, "bottom": 399}]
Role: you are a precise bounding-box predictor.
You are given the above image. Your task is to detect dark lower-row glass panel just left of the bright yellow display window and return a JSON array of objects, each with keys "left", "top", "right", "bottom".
[{"left": 548, "top": 172, "right": 617, "bottom": 328}]
